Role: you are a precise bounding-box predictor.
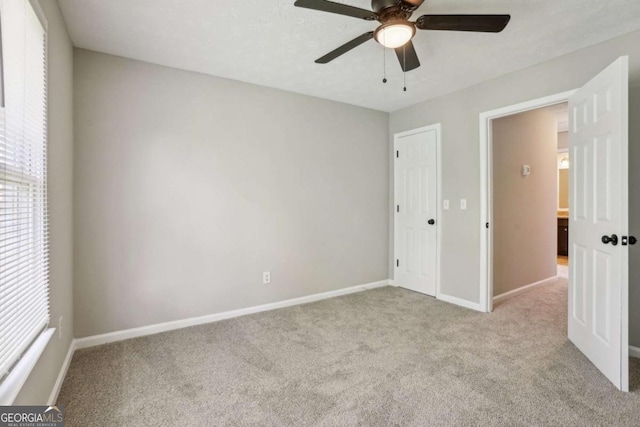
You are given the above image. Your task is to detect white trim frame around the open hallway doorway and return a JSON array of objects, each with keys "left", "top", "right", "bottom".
[{"left": 480, "top": 89, "right": 577, "bottom": 313}]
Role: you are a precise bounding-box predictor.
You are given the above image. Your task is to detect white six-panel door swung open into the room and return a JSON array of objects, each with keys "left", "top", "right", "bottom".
[{"left": 569, "top": 57, "right": 629, "bottom": 391}]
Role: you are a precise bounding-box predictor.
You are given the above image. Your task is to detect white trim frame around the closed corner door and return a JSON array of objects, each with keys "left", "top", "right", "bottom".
[{"left": 391, "top": 123, "right": 443, "bottom": 299}]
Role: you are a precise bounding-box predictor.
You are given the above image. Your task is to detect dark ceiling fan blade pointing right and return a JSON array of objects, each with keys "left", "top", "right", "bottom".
[{"left": 416, "top": 15, "right": 511, "bottom": 33}]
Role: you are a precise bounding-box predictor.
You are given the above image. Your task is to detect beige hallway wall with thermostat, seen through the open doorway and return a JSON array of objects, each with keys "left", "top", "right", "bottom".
[{"left": 492, "top": 109, "right": 558, "bottom": 296}]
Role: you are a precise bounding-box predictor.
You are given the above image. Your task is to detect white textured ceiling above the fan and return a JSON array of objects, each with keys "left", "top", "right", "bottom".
[{"left": 59, "top": 0, "right": 640, "bottom": 111}]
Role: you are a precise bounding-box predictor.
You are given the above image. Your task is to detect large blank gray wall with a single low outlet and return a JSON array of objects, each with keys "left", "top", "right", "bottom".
[{"left": 74, "top": 50, "right": 389, "bottom": 337}]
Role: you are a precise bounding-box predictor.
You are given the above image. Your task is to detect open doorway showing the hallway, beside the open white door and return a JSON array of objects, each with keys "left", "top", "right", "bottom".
[{"left": 490, "top": 102, "right": 569, "bottom": 304}]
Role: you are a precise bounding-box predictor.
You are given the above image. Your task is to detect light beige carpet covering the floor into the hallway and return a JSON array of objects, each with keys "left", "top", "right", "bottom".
[{"left": 58, "top": 280, "right": 640, "bottom": 427}]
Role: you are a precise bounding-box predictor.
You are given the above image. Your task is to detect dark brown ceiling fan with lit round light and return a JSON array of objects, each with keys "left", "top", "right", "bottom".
[{"left": 295, "top": 0, "right": 511, "bottom": 72}]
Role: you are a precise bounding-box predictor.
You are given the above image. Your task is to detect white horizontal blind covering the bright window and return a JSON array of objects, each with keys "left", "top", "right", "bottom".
[{"left": 0, "top": 0, "right": 49, "bottom": 382}]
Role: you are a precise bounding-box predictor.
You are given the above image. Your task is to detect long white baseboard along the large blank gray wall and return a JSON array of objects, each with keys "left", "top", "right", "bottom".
[{"left": 75, "top": 280, "right": 389, "bottom": 349}]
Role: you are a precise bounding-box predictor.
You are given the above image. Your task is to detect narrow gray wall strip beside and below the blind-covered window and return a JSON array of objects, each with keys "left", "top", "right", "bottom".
[{"left": 15, "top": 0, "right": 73, "bottom": 405}]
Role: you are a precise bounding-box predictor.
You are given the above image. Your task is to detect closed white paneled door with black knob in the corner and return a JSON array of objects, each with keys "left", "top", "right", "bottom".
[{"left": 394, "top": 126, "right": 440, "bottom": 296}]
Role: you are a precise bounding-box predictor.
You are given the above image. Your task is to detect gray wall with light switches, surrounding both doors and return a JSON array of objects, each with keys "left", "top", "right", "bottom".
[{"left": 389, "top": 32, "right": 640, "bottom": 345}]
